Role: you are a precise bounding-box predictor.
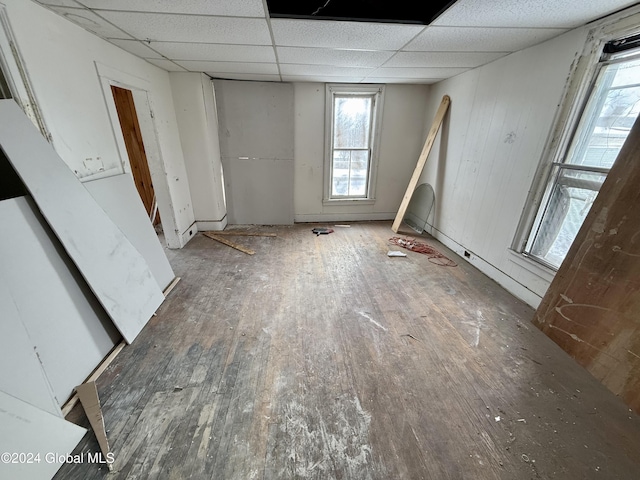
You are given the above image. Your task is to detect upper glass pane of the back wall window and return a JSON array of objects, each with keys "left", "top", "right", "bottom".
[{"left": 333, "top": 96, "right": 372, "bottom": 148}]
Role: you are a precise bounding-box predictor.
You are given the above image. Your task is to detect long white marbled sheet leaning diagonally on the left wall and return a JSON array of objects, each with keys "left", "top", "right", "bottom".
[{"left": 0, "top": 100, "right": 164, "bottom": 342}]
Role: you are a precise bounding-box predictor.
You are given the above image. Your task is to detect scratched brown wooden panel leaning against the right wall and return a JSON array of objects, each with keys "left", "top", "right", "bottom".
[{"left": 534, "top": 115, "right": 640, "bottom": 412}]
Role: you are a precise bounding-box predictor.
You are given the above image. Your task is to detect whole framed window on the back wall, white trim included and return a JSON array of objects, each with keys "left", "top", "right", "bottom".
[{"left": 325, "top": 85, "right": 383, "bottom": 201}]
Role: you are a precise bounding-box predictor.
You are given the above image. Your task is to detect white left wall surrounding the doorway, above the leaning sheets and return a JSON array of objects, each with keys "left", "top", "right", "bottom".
[{"left": 2, "top": 0, "right": 194, "bottom": 248}]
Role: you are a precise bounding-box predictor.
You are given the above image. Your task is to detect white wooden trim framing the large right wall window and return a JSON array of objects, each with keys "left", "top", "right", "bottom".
[{"left": 511, "top": 7, "right": 640, "bottom": 275}]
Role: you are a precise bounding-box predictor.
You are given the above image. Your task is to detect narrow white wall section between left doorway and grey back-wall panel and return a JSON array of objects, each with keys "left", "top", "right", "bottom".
[{"left": 169, "top": 72, "right": 227, "bottom": 230}]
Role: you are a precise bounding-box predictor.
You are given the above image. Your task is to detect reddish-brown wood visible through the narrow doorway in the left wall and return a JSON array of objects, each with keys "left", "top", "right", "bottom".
[{"left": 111, "top": 85, "right": 160, "bottom": 224}]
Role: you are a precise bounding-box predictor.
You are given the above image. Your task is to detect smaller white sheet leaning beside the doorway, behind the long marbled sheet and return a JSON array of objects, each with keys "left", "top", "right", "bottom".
[{"left": 83, "top": 173, "right": 175, "bottom": 290}]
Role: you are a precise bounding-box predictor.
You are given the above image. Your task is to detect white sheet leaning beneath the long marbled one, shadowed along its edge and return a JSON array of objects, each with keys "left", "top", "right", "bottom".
[{"left": 0, "top": 197, "right": 120, "bottom": 405}]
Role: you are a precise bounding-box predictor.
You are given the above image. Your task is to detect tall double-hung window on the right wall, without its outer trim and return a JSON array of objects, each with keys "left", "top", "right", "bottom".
[{"left": 524, "top": 42, "right": 640, "bottom": 269}]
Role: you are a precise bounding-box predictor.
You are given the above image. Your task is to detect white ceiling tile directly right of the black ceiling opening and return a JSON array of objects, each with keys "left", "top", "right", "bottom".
[{"left": 433, "top": 0, "right": 637, "bottom": 28}]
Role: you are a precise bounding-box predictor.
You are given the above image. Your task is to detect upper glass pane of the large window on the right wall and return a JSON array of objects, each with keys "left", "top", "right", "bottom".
[{"left": 566, "top": 60, "right": 640, "bottom": 168}]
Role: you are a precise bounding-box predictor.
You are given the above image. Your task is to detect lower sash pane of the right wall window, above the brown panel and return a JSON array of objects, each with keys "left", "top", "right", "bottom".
[{"left": 530, "top": 169, "right": 606, "bottom": 268}]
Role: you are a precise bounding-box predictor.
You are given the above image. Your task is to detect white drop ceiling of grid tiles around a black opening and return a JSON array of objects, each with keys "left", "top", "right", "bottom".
[{"left": 33, "top": 0, "right": 637, "bottom": 83}]
